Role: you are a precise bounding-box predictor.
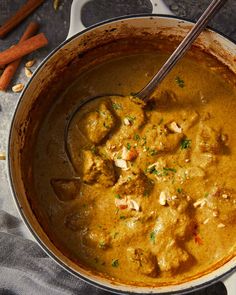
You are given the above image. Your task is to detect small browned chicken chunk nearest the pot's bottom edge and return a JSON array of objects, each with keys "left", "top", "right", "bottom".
[{"left": 127, "top": 248, "right": 157, "bottom": 277}]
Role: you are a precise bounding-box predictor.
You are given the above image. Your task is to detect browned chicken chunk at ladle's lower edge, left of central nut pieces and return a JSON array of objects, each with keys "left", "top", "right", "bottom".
[{"left": 83, "top": 150, "right": 116, "bottom": 187}]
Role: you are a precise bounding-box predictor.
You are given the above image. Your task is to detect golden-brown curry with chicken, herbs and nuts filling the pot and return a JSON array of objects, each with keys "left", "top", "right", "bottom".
[{"left": 34, "top": 44, "right": 236, "bottom": 285}]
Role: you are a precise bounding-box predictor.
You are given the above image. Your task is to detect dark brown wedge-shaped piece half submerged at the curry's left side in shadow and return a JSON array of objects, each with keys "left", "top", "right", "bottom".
[{"left": 51, "top": 179, "right": 80, "bottom": 202}]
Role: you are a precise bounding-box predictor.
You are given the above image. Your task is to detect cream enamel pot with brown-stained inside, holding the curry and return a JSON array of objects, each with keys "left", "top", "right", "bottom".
[{"left": 8, "top": 0, "right": 236, "bottom": 295}]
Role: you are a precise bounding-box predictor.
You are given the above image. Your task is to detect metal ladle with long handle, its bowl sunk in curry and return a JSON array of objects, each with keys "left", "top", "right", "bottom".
[{"left": 64, "top": 0, "right": 227, "bottom": 159}]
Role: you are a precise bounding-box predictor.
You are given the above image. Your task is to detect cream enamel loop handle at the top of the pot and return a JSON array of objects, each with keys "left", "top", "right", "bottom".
[{"left": 66, "top": 0, "right": 173, "bottom": 39}]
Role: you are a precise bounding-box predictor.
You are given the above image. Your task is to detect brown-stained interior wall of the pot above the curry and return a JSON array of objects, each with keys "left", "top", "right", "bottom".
[{"left": 9, "top": 17, "right": 236, "bottom": 292}]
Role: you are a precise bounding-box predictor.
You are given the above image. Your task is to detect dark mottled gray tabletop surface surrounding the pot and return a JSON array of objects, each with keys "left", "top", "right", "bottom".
[{"left": 0, "top": 0, "right": 236, "bottom": 295}]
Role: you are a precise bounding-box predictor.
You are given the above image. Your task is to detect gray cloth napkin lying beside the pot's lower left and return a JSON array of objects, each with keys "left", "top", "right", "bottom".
[{"left": 0, "top": 211, "right": 110, "bottom": 295}]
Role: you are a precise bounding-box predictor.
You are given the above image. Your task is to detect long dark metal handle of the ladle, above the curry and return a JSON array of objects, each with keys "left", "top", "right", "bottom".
[{"left": 136, "top": 0, "right": 227, "bottom": 101}]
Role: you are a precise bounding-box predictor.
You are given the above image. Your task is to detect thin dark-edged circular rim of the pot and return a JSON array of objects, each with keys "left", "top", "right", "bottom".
[{"left": 6, "top": 13, "right": 236, "bottom": 295}]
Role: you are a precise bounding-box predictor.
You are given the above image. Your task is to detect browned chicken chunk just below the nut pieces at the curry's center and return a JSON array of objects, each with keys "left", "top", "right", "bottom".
[{"left": 114, "top": 171, "right": 153, "bottom": 196}]
